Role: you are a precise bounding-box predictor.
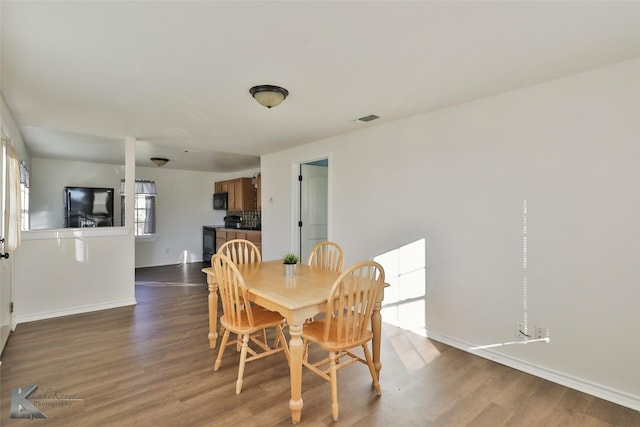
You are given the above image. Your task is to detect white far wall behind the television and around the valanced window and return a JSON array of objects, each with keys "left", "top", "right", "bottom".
[{"left": 31, "top": 159, "right": 240, "bottom": 267}]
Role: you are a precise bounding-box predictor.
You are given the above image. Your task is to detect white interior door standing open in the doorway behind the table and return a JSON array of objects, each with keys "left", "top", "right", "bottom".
[{"left": 300, "top": 162, "right": 329, "bottom": 262}]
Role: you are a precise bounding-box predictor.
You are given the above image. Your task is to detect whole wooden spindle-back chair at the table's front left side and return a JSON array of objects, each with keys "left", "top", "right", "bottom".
[{"left": 211, "top": 253, "right": 289, "bottom": 394}]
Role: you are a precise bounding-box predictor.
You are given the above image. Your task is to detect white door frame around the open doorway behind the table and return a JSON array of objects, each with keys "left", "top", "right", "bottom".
[{"left": 291, "top": 154, "right": 333, "bottom": 262}]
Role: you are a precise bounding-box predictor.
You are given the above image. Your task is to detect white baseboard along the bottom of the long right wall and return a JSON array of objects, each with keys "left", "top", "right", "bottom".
[{"left": 427, "top": 331, "right": 640, "bottom": 411}]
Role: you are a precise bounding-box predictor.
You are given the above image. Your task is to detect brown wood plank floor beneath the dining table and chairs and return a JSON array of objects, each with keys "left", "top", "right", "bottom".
[{"left": 0, "top": 264, "right": 640, "bottom": 427}]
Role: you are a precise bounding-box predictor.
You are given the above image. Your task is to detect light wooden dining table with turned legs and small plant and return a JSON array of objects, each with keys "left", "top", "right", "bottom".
[{"left": 202, "top": 260, "right": 383, "bottom": 424}]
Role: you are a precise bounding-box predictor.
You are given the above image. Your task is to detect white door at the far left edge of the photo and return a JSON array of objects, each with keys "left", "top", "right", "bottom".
[{"left": 0, "top": 140, "right": 11, "bottom": 353}]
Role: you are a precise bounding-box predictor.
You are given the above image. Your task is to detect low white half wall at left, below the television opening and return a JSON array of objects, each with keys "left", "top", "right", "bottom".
[{"left": 12, "top": 227, "right": 136, "bottom": 324}]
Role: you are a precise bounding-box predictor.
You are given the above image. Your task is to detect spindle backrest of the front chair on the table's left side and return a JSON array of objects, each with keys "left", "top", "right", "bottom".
[{"left": 211, "top": 253, "right": 253, "bottom": 326}]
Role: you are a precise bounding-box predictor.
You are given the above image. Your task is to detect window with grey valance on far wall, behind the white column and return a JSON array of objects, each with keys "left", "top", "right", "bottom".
[{"left": 120, "top": 179, "right": 157, "bottom": 238}]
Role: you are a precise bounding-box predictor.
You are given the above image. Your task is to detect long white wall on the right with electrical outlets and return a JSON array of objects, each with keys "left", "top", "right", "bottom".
[{"left": 261, "top": 60, "right": 640, "bottom": 409}]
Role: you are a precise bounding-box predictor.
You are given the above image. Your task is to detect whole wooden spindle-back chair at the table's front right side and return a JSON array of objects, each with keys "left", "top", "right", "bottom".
[{"left": 302, "top": 261, "right": 384, "bottom": 421}]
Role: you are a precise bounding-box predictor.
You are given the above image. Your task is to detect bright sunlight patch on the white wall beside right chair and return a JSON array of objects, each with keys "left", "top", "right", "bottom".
[{"left": 374, "top": 239, "right": 427, "bottom": 336}]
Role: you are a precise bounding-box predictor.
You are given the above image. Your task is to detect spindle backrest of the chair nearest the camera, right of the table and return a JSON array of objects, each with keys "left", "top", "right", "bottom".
[{"left": 323, "top": 261, "right": 384, "bottom": 343}]
